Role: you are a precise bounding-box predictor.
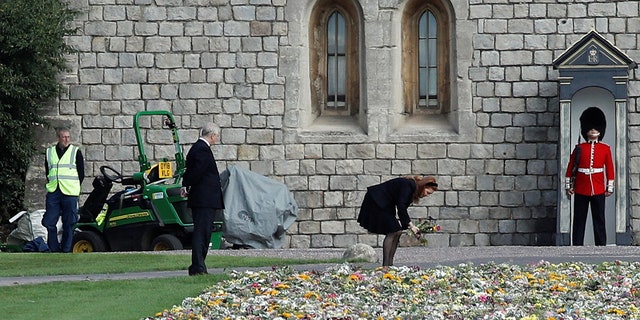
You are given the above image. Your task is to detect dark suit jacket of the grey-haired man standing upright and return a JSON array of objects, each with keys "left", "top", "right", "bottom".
[{"left": 182, "top": 139, "right": 224, "bottom": 209}]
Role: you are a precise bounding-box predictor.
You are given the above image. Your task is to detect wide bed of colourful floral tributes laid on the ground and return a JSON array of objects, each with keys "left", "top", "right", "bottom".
[{"left": 147, "top": 261, "right": 640, "bottom": 320}]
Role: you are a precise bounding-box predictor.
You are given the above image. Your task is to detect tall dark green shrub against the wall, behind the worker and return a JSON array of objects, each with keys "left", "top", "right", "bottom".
[{"left": 0, "top": 0, "right": 77, "bottom": 220}]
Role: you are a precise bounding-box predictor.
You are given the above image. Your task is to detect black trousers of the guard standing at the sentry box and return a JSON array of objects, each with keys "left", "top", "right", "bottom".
[{"left": 572, "top": 194, "right": 607, "bottom": 246}]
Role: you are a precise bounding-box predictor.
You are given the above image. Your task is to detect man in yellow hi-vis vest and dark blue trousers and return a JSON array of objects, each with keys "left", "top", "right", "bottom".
[{"left": 42, "top": 128, "right": 84, "bottom": 252}]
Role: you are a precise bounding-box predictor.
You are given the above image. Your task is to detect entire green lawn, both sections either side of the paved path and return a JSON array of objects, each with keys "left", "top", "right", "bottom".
[{"left": 0, "top": 253, "right": 341, "bottom": 320}]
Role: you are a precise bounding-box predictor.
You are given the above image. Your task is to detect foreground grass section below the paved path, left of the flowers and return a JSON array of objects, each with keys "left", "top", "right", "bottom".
[{"left": 0, "top": 274, "right": 227, "bottom": 320}]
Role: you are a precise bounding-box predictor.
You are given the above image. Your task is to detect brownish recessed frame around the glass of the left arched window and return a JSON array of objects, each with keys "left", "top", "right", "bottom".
[{"left": 309, "top": 0, "right": 361, "bottom": 122}]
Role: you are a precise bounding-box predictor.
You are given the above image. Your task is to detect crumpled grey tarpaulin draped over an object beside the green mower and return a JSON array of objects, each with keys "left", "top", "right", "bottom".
[{"left": 220, "top": 166, "right": 298, "bottom": 249}]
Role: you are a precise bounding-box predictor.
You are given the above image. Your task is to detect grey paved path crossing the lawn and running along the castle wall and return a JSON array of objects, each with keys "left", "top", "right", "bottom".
[{"left": 0, "top": 246, "right": 640, "bottom": 287}]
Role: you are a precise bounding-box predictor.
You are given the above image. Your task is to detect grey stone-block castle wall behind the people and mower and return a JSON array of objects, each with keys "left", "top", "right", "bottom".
[{"left": 27, "top": 0, "right": 640, "bottom": 248}]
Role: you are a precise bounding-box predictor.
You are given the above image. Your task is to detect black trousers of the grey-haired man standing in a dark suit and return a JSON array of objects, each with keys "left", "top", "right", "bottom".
[{"left": 189, "top": 208, "right": 222, "bottom": 275}]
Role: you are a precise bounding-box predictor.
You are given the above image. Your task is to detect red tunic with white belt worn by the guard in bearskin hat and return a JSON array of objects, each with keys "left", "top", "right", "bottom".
[{"left": 565, "top": 142, "right": 615, "bottom": 196}]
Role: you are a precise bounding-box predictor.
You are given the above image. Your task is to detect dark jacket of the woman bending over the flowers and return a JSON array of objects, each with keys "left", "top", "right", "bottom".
[{"left": 367, "top": 178, "right": 417, "bottom": 229}]
